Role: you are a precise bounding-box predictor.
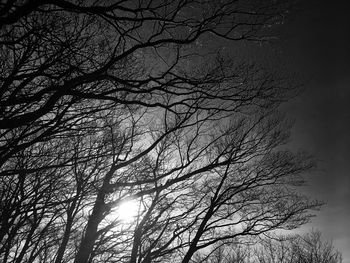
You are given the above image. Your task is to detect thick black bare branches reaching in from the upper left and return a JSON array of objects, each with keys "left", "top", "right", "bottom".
[{"left": 0, "top": 0, "right": 296, "bottom": 170}]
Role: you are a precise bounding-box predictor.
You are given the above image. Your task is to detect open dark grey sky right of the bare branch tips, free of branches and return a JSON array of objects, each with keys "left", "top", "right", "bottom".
[{"left": 273, "top": 0, "right": 350, "bottom": 263}]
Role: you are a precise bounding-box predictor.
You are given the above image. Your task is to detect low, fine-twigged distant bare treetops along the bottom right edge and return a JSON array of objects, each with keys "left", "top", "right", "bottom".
[{"left": 192, "top": 230, "right": 342, "bottom": 263}]
